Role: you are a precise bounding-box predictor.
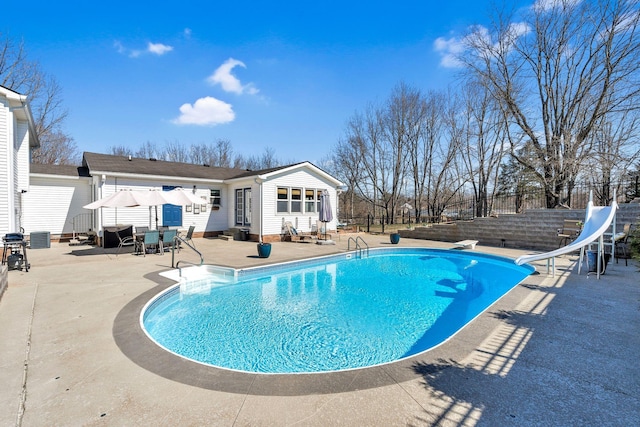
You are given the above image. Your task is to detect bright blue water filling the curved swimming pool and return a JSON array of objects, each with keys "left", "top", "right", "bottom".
[{"left": 141, "top": 249, "right": 533, "bottom": 373}]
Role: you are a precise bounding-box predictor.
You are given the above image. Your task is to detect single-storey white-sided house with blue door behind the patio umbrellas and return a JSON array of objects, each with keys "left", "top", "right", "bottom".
[{"left": 21, "top": 152, "right": 343, "bottom": 242}]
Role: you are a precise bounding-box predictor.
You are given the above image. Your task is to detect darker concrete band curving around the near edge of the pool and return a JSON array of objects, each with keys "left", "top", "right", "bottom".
[{"left": 112, "top": 254, "right": 545, "bottom": 396}]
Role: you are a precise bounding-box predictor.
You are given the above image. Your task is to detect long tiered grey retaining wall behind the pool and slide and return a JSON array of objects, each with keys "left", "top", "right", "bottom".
[{"left": 399, "top": 203, "right": 640, "bottom": 251}]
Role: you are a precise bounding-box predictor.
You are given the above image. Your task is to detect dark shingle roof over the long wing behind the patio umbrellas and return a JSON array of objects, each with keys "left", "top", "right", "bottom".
[{"left": 82, "top": 153, "right": 255, "bottom": 180}]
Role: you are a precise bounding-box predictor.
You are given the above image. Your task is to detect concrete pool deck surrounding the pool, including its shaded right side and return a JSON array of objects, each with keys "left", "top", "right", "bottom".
[{"left": 0, "top": 235, "right": 640, "bottom": 426}]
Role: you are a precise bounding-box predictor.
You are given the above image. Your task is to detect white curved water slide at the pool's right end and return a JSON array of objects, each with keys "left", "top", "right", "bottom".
[{"left": 515, "top": 192, "right": 618, "bottom": 277}]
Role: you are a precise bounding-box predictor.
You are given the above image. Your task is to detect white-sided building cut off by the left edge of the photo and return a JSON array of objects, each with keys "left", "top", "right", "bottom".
[{"left": 0, "top": 86, "right": 40, "bottom": 236}]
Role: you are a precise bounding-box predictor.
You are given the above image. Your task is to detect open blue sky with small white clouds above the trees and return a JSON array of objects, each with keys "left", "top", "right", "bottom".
[{"left": 6, "top": 0, "right": 530, "bottom": 162}]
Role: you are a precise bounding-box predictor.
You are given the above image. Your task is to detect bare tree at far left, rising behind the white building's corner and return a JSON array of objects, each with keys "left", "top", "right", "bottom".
[{"left": 0, "top": 33, "right": 80, "bottom": 164}]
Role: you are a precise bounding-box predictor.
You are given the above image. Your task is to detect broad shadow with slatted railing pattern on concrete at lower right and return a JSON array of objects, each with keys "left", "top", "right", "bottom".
[{"left": 412, "top": 264, "right": 640, "bottom": 426}]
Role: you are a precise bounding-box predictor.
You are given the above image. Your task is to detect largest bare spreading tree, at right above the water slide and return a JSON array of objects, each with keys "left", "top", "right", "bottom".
[{"left": 461, "top": 0, "right": 640, "bottom": 207}]
